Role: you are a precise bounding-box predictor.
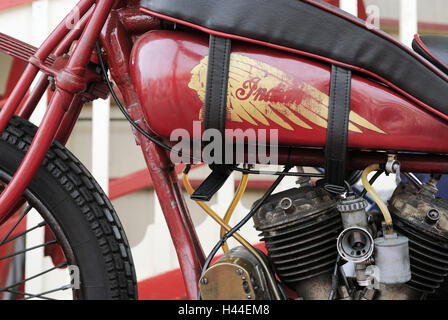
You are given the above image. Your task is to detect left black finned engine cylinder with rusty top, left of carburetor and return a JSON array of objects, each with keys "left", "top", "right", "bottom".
[{"left": 254, "top": 186, "right": 342, "bottom": 287}]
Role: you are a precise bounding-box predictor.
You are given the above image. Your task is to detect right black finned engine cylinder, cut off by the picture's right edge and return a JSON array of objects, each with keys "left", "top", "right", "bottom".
[{"left": 389, "top": 184, "right": 448, "bottom": 294}]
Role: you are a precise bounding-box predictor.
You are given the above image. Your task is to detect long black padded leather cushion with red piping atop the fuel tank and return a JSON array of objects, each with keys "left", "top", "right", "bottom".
[{"left": 141, "top": 0, "right": 448, "bottom": 115}]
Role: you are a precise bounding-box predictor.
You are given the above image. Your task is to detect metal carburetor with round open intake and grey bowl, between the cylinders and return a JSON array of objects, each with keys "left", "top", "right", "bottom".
[{"left": 337, "top": 189, "right": 411, "bottom": 300}]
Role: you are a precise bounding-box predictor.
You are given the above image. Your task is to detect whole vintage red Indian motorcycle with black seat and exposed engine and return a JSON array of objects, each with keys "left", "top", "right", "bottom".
[{"left": 0, "top": 0, "right": 448, "bottom": 300}]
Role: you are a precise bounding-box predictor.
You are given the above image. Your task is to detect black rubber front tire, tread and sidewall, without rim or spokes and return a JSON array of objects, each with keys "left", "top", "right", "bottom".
[{"left": 0, "top": 117, "right": 137, "bottom": 300}]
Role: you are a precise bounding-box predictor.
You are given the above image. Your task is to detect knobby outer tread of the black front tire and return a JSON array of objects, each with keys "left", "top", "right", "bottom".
[{"left": 1, "top": 116, "right": 137, "bottom": 299}]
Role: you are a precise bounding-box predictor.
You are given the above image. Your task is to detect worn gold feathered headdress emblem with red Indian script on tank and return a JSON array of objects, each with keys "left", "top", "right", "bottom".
[{"left": 188, "top": 53, "right": 386, "bottom": 134}]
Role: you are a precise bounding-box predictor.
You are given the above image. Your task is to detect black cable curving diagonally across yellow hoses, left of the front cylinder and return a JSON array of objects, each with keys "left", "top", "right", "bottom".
[{"left": 198, "top": 166, "right": 292, "bottom": 300}]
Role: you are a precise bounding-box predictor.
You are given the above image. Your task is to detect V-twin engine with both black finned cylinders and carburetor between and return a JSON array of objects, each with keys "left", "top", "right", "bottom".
[{"left": 253, "top": 176, "right": 448, "bottom": 300}]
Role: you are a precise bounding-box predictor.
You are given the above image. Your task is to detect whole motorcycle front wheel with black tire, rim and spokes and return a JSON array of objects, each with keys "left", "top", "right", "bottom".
[{"left": 0, "top": 117, "right": 137, "bottom": 300}]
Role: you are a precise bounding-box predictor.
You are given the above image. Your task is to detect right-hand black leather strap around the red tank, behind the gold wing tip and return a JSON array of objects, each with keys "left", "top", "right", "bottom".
[{"left": 325, "top": 65, "right": 352, "bottom": 186}]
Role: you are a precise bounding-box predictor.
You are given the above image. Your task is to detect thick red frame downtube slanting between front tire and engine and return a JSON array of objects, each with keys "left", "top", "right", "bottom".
[{"left": 101, "top": 7, "right": 205, "bottom": 299}]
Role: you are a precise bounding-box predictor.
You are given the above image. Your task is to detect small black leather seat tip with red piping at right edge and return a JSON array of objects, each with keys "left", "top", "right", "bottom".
[{"left": 412, "top": 35, "right": 448, "bottom": 74}]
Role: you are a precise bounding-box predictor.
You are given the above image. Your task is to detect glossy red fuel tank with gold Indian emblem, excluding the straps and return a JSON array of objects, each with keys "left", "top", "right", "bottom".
[{"left": 131, "top": 31, "right": 448, "bottom": 153}]
